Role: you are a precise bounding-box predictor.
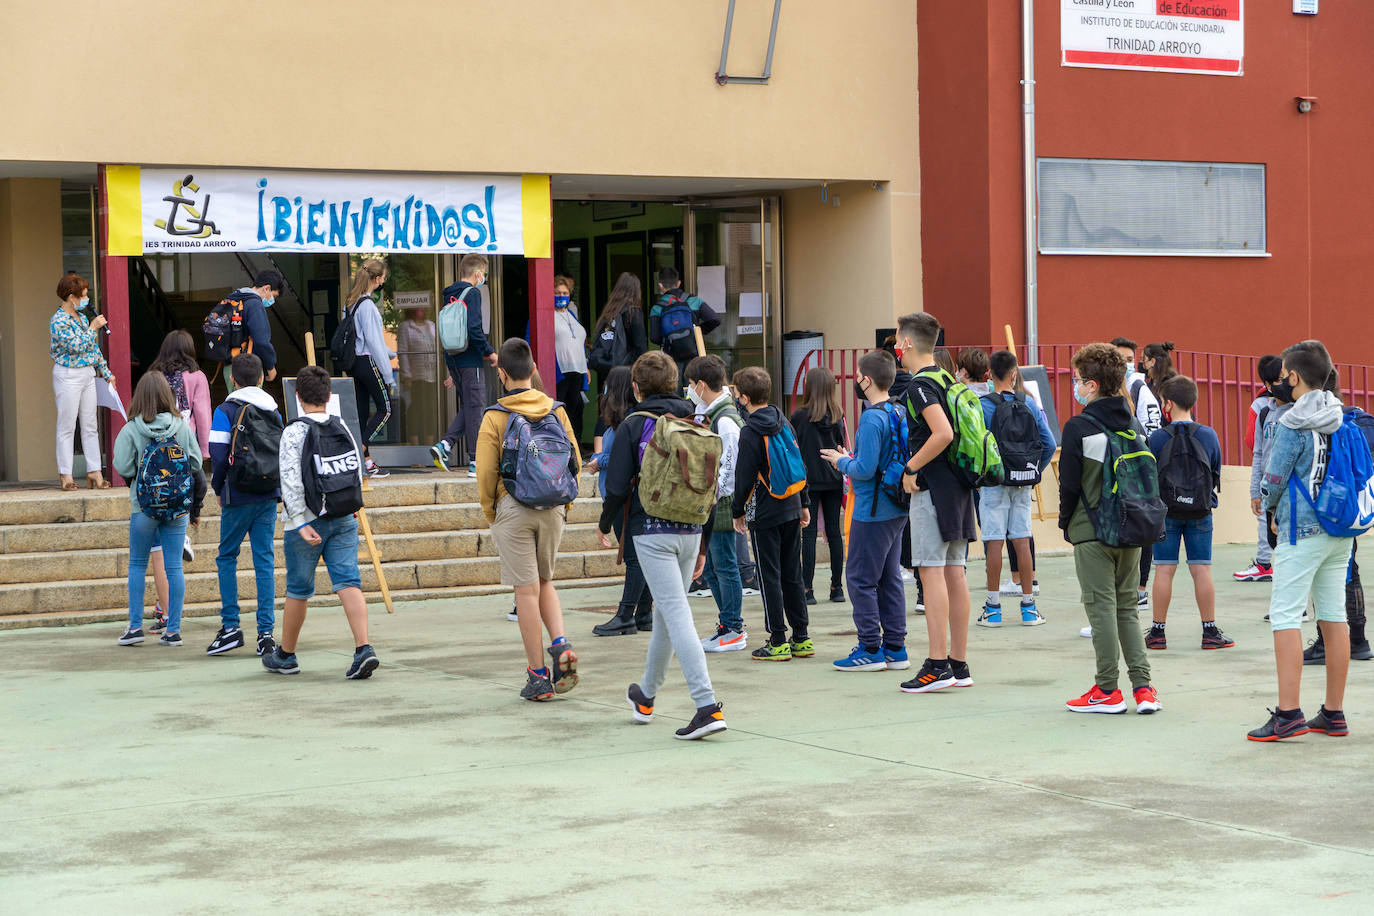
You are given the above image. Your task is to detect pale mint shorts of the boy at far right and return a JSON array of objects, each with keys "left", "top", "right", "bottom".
[{"left": 1270, "top": 529, "right": 1355, "bottom": 630}]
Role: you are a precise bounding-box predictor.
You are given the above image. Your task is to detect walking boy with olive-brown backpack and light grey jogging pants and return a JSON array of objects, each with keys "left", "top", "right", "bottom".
[{"left": 598, "top": 350, "right": 738, "bottom": 740}]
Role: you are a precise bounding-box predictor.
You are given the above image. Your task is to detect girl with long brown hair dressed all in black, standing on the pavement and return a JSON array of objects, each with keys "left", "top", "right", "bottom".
[{"left": 791, "top": 365, "right": 846, "bottom": 604}]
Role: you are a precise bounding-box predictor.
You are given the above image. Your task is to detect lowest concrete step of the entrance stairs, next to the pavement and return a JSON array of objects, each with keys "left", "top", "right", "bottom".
[{"left": 0, "top": 549, "right": 624, "bottom": 617}]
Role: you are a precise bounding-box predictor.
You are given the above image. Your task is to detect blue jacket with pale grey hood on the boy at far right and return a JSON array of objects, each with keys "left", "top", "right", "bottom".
[{"left": 1260, "top": 391, "right": 1342, "bottom": 541}]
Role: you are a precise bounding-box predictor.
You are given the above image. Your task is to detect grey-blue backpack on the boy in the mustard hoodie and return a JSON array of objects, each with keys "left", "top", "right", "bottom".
[{"left": 486, "top": 401, "right": 577, "bottom": 509}]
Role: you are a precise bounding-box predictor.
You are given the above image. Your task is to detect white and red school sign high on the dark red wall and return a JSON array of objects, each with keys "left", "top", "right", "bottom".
[{"left": 1059, "top": 0, "right": 1245, "bottom": 77}]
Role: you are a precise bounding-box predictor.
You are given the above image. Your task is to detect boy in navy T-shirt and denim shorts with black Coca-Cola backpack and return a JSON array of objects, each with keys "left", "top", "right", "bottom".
[{"left": 1145, "top": 374, "right": 1235, "bottom": 650}]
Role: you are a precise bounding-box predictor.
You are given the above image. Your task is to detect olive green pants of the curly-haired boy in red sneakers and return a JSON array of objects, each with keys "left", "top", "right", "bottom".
[{"left": 1073, "top": 541, "right": 1150, "bottom": 694}]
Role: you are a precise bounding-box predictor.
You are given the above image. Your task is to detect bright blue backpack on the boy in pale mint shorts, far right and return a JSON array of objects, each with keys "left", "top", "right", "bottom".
[{"left": 1289, "top": 409, "right": 1374, "bottom": 544}]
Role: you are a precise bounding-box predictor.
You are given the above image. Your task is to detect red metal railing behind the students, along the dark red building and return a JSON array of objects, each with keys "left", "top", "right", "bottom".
[{"left": 786, "top": 343, "right": 1374, "bottom": 464}]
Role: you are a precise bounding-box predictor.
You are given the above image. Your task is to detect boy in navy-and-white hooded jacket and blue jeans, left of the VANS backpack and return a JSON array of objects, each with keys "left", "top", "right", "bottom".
[{"left": 205, "top": 353, "right": 282, "bottom": 655}]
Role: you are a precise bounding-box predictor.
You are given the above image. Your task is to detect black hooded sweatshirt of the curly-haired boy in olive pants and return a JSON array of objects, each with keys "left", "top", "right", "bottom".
[{"left": 1059, "top": 397, "right": 1146, "bottom": 544}]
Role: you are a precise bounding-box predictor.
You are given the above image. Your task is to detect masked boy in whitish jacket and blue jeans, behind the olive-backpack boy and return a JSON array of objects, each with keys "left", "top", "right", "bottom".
[{"left": 687, "top": 354, "right": 749, "bottom": 652}]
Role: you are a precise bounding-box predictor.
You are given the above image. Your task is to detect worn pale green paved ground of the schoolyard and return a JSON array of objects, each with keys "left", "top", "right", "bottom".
[{"left": 0, "top": 548, "right": 1374, "bottom": 913}]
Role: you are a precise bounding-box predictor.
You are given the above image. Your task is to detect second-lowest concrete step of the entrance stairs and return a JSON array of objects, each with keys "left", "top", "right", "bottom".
[{"left": 0, "top": 523, "right": 600, "bottom": 584}]
